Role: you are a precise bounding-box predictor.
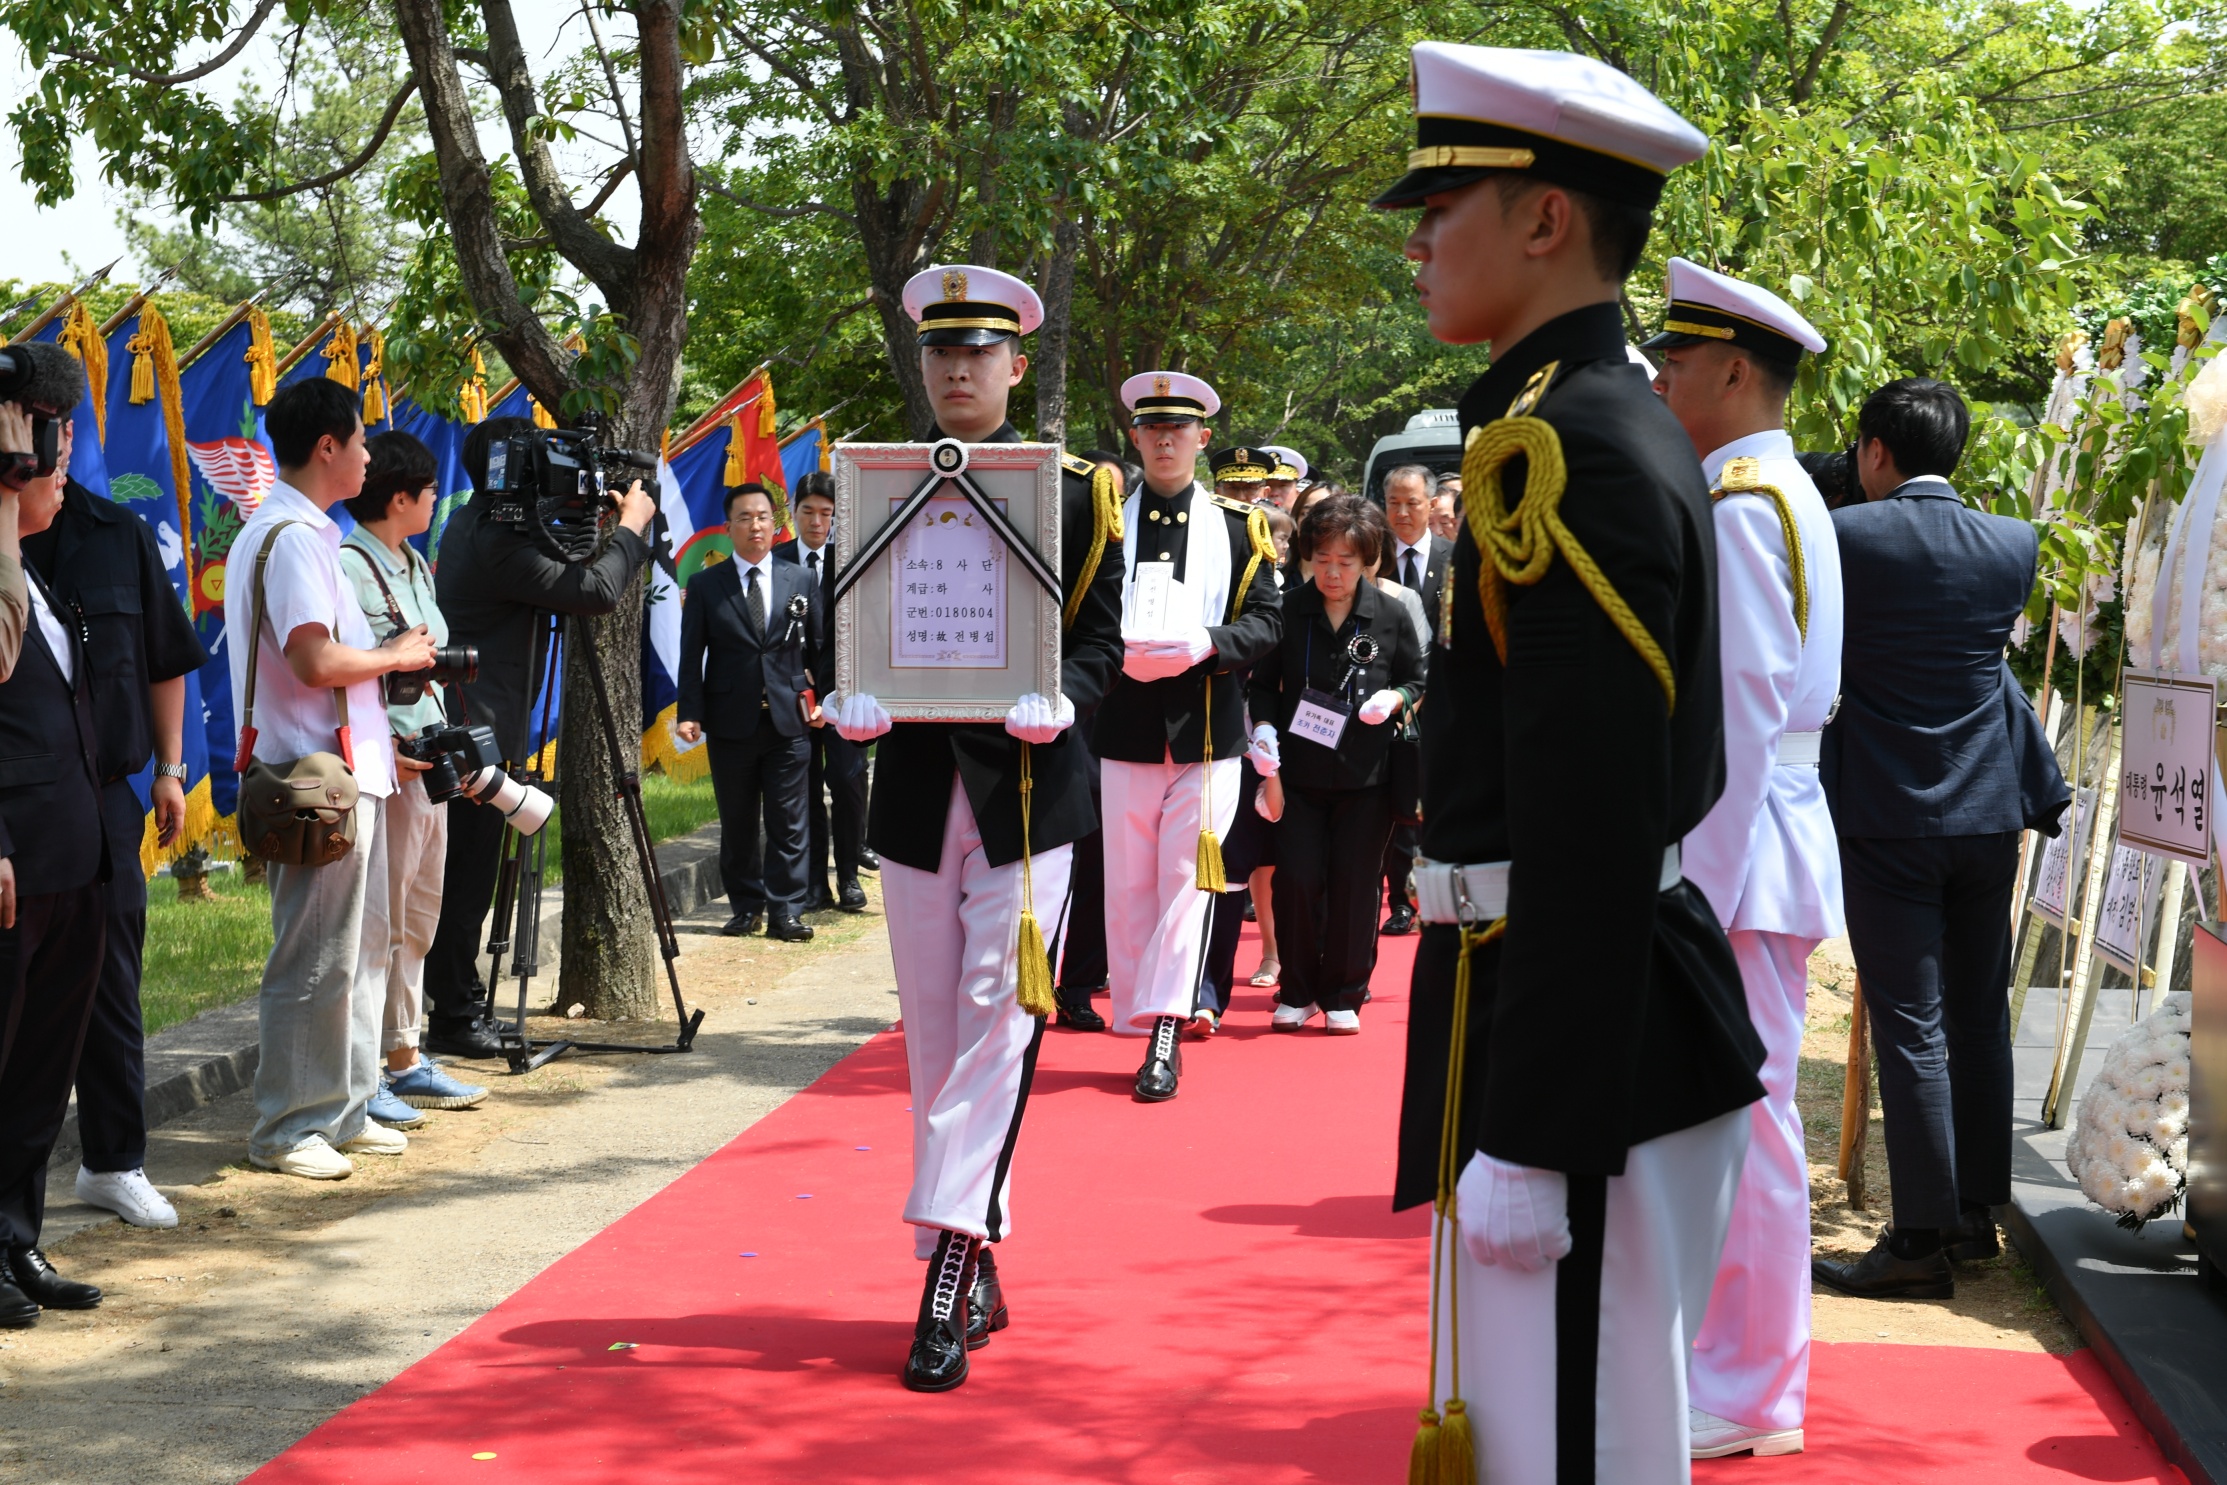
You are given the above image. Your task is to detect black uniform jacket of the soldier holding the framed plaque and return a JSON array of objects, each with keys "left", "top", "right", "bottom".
[{"left": 866, "top": 423, "right": 1122, "bottom": 871}]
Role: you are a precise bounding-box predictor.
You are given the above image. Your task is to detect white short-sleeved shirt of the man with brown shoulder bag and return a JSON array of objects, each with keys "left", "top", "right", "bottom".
[{"left": 225, "top": 479, "right": 394, "bottom": 799}]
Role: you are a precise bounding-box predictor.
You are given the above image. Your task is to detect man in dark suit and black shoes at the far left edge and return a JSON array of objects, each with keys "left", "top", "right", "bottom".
[{"left": 0, "top": 378, "right": 111, "bottom": 1327}]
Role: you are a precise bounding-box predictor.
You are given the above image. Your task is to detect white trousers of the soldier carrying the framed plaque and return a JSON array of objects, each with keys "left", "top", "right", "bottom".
[{"left": 882, "top": 779, "right": 1076, "bottom": 1258}]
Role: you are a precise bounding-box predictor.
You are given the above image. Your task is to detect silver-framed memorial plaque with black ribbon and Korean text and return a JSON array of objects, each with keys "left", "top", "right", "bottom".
[{"left": 831, "top": 439, "right": 1065, "bottom": 721}]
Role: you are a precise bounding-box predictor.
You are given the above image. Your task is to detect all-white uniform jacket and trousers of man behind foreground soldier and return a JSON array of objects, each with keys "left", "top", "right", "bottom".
[{"left": 1684, "top": 430, "right": 1844, "bottom": 1429}]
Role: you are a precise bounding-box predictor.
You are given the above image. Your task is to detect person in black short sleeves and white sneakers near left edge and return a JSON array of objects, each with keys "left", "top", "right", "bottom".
[{"left": 22, "top": 409, "right": 209, "bottom": 1227}]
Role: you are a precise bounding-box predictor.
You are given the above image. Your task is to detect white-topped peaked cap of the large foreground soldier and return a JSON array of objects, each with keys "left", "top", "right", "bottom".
[{"left": 1370, "top": 42, "right": 1708, "bottom": 209}]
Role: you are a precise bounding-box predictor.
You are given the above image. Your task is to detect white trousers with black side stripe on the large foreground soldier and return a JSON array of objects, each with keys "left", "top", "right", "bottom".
[{"left": 1434, "top": 1109, "right": 1748, "bottom": 1485}]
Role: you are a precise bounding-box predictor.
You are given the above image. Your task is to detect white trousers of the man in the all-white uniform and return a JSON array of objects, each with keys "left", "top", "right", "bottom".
[{"left": 1690, "top": 933, "right": 1819, "bottom": 1429}]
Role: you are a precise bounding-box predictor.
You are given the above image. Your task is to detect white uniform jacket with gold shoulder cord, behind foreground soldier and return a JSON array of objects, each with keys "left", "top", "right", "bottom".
[{"left": 1684, "top": 430, "right": 1842, "bottom": 940}]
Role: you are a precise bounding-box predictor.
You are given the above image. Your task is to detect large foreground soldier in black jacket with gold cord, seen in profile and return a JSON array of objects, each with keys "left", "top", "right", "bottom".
[{"left": 1374, "top": 42, "right": 1764, "bottom": 1485}]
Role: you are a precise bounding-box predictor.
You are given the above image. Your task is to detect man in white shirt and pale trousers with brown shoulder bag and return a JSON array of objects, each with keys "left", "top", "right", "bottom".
[{"left": 225, "top": 376, "right": 434, "bottom": 1180}]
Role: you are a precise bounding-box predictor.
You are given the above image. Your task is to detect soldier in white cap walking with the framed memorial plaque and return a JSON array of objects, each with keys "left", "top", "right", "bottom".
[{"left": 828, "top": 265, "right": 1120, "bottom": 1391}]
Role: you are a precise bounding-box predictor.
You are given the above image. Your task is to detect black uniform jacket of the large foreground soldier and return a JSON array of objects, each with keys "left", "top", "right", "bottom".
[{"left": 1394, "top": 303, "right": 1764, "bottom": 1207}]
